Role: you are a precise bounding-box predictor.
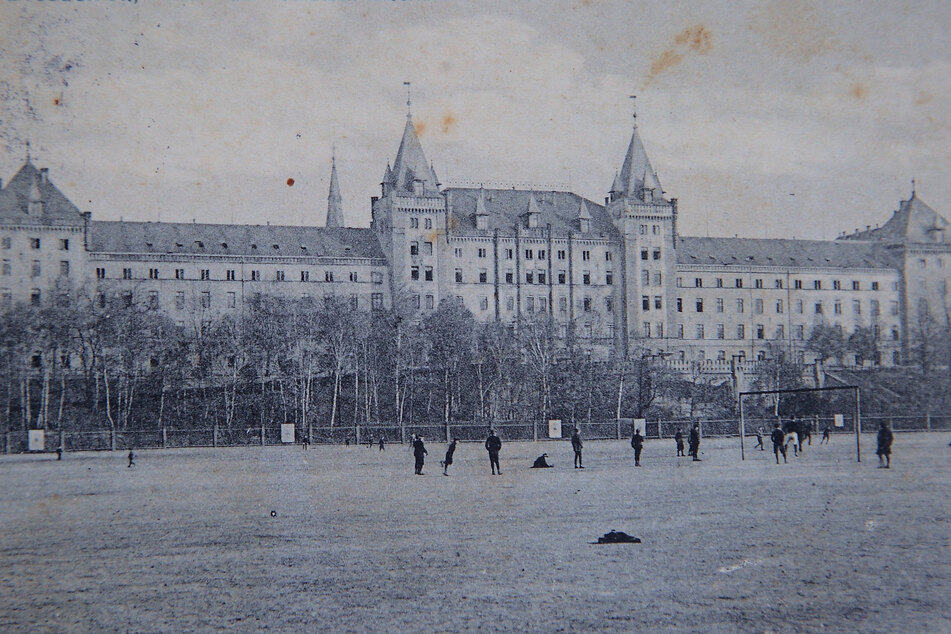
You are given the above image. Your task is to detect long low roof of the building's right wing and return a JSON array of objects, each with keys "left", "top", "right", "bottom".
[{"left": 677, "top": 237, "right": 898, "bottom": 269}]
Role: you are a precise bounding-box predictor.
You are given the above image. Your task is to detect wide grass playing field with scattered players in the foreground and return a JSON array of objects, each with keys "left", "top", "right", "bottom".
[{"left": 0, "top": 434, "right": 951, "bottom": 632}]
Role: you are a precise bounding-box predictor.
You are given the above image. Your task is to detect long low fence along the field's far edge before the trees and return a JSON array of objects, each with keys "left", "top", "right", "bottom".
[{"left": 0, "top": 414, "right": 951, "bottom": 454}]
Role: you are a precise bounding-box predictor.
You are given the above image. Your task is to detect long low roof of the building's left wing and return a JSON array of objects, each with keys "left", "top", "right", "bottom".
[{"left": 89, "top": 221, "right": 383, "bottom": 258}]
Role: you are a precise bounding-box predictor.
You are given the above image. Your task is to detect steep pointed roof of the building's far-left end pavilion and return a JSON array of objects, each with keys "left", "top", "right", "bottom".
[{"left": 0, "top": 160, "right": 83, "bottom": 226}]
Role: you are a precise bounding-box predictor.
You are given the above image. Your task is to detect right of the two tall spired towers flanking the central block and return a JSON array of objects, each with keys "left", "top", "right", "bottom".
[{"left": 606, "top": 103, "right": 679, "bottom": 346}]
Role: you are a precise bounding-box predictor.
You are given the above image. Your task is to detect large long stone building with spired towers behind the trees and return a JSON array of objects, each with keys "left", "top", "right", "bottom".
[{"left": 0, "top": 108, "right": 951, "bottom": 365}]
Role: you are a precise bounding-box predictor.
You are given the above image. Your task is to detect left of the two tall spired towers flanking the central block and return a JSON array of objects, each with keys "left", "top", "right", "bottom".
[{"left": 371, "top": 82, "right": 448, "bottom": 312}]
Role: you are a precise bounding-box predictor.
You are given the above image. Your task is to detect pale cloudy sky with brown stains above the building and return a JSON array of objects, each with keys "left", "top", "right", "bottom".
[{"left": 0, "top": 0, "right": 951, "bottom": 238}]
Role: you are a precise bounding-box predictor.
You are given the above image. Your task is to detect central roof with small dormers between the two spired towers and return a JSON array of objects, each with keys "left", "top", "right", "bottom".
[{"left": 446, "top": 187, "right": 620, "bottom": 240}]
